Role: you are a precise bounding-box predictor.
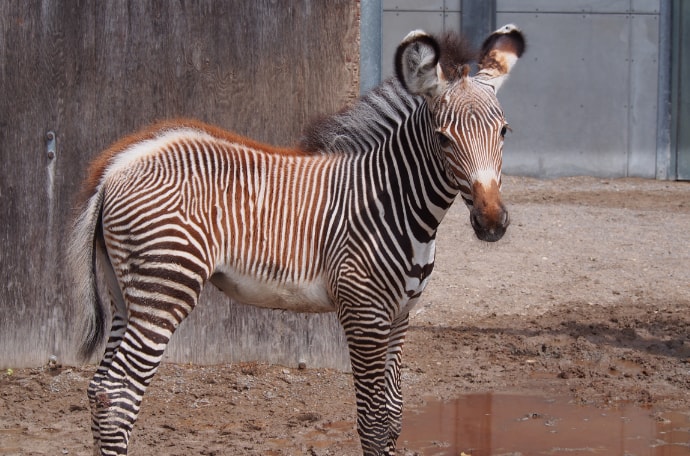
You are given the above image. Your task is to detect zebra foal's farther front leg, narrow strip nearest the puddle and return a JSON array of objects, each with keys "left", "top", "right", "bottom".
[{"left": 386, "top": 314, "right": 409, "bottom": 456}]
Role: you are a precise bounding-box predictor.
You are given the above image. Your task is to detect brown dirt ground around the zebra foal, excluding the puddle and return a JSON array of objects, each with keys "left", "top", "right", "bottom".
[{"left": 0, "top": 177, "right": 690, "bottom": 456}]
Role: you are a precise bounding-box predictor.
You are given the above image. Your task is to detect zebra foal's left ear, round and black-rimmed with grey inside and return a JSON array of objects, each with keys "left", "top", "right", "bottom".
[{"left": 395, "top": 30, "right": 447, "bottom": 98}]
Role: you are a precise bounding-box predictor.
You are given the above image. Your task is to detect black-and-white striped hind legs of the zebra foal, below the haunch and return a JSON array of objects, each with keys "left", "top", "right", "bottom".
[{"left": 92, "top": 257, "right": 206, "bottom": 456}]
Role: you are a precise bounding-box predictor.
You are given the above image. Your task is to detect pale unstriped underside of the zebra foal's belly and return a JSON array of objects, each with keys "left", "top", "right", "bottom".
[{"left": 211, "top": 270, "right": 335, "bottom": 312}]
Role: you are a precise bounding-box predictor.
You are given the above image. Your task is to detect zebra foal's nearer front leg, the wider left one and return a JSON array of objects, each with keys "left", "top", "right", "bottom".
[{"left": 340, "top": 311, "right": 390, "bottom": 456}]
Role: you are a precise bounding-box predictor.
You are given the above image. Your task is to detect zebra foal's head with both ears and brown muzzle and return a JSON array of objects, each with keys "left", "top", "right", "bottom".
[{"left": 395, "top": 25, "right": 525, "bottom": 242}]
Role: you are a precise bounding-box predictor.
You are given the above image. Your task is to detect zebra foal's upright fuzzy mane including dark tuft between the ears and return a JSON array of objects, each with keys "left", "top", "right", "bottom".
[{"left": 298, "top": 32, "right": 478, "bottom": 153}]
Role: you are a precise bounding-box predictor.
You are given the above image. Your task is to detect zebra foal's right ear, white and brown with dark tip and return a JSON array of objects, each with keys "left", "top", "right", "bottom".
[{"left": 476, "top": 24, "right": 525, "bottom": 91}]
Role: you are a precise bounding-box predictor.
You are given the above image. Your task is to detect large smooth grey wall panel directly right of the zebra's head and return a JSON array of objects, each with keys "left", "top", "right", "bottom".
[{"left": 497, "top": 13, "right": 636, "bottom": 177}]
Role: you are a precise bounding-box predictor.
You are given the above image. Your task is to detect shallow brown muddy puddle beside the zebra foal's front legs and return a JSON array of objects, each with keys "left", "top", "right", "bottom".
[{"left": 398, "top": 394, "right": 690, "bottom": 456}]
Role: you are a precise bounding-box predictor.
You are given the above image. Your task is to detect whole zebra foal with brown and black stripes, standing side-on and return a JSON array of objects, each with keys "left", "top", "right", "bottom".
[{"left": 69, "top": 25, "right": 524, "bottom": 456}]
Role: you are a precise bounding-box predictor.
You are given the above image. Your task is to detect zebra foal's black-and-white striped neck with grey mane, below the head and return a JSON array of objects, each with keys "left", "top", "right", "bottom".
[{"left": 301, "top": 79, "right": 458, "bottom": 242}]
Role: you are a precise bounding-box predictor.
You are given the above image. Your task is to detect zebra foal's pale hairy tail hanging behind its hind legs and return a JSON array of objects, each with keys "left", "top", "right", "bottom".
[{"left": 67, "top": 186, "right": 106, "bottom": 361}]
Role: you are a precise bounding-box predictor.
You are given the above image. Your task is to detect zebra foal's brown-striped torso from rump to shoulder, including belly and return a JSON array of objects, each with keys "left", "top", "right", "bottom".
[{"left": 95, "top": 123, "right": 340, "bottom": 312}]
